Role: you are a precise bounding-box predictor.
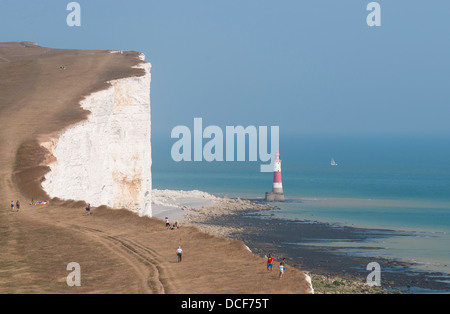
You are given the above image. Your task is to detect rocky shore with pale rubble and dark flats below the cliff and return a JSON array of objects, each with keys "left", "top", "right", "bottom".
[{"left": 154, "top": 190, "right": 449, "bottom": 293}]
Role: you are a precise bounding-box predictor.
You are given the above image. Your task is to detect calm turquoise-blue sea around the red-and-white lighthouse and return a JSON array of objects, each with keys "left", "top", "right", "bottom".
[{"left": 152, "top": 135, "right": 450, "bottom": 290}]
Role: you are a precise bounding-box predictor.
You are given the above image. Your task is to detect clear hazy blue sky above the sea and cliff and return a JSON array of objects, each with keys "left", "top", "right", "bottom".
[{"left": 0, "top": 0, "right": 450, "bottom": 137}]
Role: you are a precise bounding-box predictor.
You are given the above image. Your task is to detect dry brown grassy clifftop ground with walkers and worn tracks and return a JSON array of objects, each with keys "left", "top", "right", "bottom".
[{"left": 0, "top": 43, "right": 310, "bottom": 293}]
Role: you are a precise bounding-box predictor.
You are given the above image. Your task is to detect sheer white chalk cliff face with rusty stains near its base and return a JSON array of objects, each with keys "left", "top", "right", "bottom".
[{"left": 42, "top": 57, "right": 152, "bottom": 216}]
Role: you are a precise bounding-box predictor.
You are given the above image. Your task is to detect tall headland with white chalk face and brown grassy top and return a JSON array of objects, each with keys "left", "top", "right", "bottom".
[{"left": 0, "top": 42, "right": 151, "bottom": 216}]
